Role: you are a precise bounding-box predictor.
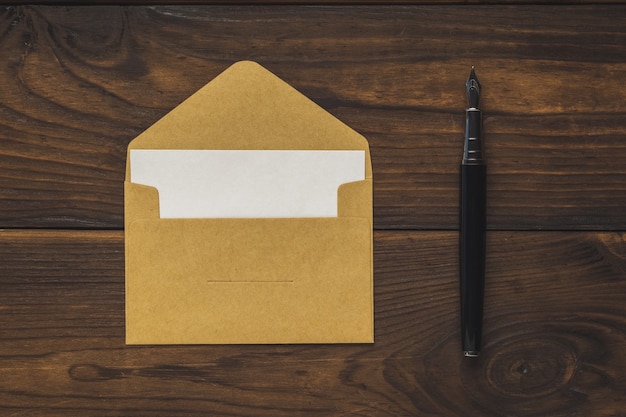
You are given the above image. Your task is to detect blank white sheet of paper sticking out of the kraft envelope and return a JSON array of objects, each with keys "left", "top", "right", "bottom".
[{"left": 130, "top": 149, "right": 365, "bottom": 218}]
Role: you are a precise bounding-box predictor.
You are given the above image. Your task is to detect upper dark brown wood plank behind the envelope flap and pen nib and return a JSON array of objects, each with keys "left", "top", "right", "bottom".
[{"left": 0, "top": 5, "right": 626, "bottom": 230}]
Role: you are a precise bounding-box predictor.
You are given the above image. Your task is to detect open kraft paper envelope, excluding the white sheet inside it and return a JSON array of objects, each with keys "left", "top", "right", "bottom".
[{"left": 124, "top": 62, "right": 374, "bottom": 344}]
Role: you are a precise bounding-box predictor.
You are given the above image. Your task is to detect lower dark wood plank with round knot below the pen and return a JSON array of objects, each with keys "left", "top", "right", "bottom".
[{"left": 0, "top": 230, "right": 626, "bottom": 417}]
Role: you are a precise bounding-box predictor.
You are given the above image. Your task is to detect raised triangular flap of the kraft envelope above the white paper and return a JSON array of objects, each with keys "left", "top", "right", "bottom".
[{"left": 126, "top": 61, "right": 371, "bottom": 180}]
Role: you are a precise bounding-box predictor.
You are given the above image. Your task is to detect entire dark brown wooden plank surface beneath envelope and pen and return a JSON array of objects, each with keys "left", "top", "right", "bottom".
[{"left": 0, "top": 4, "right": 626, "bottom": 417}]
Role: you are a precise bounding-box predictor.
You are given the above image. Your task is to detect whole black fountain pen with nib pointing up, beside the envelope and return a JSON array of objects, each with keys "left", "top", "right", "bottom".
[{"left": 460, "top": 67, "right": 487, "bottom": 357}]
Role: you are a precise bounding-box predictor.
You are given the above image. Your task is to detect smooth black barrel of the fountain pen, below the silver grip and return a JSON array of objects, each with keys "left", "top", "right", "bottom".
[{"left": 460, "top": 163, "right": 487, "bottom": 356}]
